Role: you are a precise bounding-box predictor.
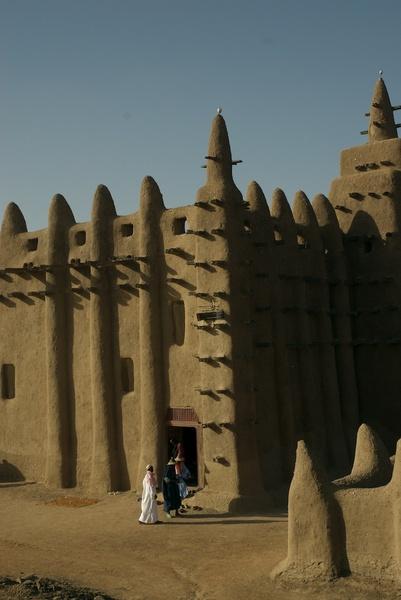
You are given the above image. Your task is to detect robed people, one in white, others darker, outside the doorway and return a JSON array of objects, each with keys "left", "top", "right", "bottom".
[{"left": 139, "top": 441, "right": 191, "bottom": 525}]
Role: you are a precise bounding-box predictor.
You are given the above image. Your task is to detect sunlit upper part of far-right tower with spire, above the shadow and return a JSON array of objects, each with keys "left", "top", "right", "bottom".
[{"left": 329, "top": 76, "right": 401, "bottom": 239}]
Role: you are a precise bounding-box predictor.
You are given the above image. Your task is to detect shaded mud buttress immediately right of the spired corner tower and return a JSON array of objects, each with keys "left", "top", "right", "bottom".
[{"left": 244, "top": 181, "right": 282, "bottom": 489}]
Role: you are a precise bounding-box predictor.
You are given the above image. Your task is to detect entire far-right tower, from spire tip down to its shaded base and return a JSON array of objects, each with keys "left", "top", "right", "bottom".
[{"left": 327, "top": 76, "right": 401, "bottom": 451}]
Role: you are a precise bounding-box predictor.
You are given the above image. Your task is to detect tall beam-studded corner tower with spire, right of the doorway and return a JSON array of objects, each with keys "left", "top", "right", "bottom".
[{"left": 193, "top": 111, "right": 266, "bottom": 509}]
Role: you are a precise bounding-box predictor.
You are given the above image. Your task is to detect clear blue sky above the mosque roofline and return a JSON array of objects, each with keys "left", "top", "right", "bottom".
[{"left": 0, "top": 0, "right": 401, "bottom": 229}]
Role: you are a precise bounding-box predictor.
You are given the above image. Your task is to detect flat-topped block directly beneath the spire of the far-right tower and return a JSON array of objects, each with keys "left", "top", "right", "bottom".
[{"left": 340, "top": 138, "right": 401, "bottom": 176}]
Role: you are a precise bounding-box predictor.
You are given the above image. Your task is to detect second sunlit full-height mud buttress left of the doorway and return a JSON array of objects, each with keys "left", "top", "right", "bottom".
[{"left": 89, "top": 185, "right": 118, "bottom": 493}]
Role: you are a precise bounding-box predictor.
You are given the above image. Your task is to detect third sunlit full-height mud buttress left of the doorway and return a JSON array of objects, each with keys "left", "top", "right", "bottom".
[{"left": 45, "top": 195, "right": 75, "bottom": 487}]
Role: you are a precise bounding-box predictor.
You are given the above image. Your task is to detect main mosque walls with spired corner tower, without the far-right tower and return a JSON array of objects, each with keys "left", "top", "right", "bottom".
[{"left": 0, "top": 115, "right": 357, "bottom": 510}]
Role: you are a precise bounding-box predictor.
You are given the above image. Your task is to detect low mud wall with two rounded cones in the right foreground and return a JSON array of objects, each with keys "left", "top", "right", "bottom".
[{"left": 272, "top": 425, "right": 401, "bottom": 582}]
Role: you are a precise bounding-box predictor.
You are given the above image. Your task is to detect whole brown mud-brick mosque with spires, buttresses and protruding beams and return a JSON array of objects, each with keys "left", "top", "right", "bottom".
[{"left": 0, "top": 78, "right": 401, "bottom": 510}]
